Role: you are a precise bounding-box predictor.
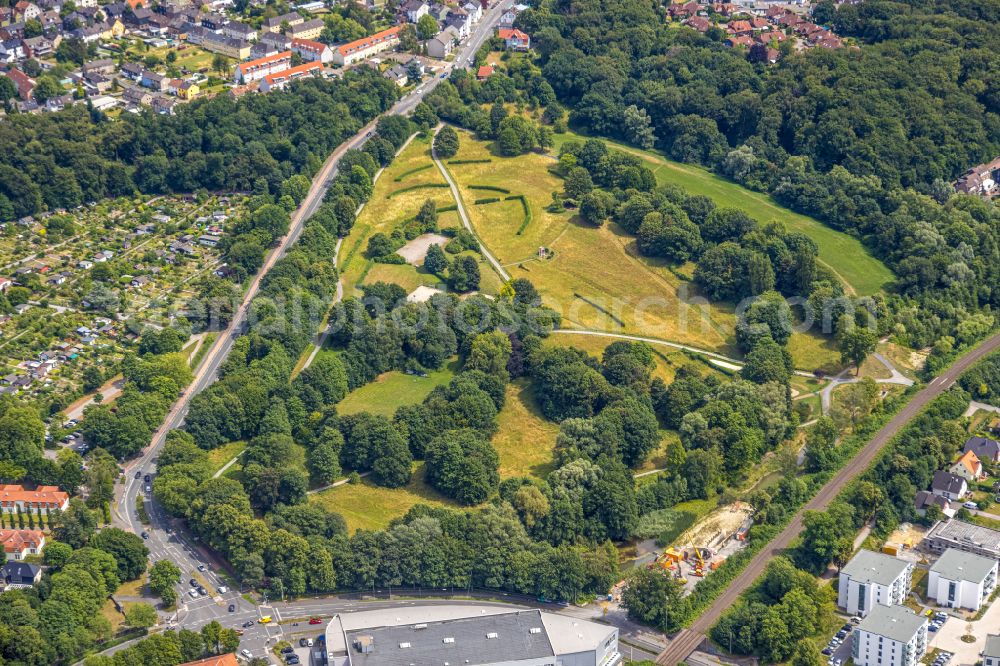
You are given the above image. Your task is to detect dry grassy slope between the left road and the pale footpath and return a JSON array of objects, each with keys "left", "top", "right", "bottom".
[{"left": 338, "top": 138, "right": 455, "bottom": 298}]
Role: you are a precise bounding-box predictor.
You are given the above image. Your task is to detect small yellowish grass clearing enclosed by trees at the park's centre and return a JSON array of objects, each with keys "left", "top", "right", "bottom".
[{"left": 492, "top": 379, "right": 559, "bottom": 479}]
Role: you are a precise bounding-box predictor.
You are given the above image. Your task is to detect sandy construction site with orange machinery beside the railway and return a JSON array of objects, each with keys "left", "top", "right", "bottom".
[{"left": 648, "top": 502, "right": 753, "bottom": 594}]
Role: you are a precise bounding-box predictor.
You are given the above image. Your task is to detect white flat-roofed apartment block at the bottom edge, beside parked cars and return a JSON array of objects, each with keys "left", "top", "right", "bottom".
[{"left": 852, "top": 606, "right": 927, "bottom": 666}]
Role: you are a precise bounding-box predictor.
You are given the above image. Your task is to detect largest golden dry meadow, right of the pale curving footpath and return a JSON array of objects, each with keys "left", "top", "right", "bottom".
[{"left": 450, "top": 132, "right": 735, "bottom": 353}]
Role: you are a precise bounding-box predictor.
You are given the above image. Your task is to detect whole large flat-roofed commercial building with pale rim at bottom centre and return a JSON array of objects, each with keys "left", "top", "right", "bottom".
[{"left": 325, "top": 605, "right": 622, "bottom": 666}]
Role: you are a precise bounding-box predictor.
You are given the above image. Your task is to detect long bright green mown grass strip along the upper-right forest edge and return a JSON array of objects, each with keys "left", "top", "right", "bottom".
[{"left": 555, "top": 132, "right": 895, "bottom": 296}]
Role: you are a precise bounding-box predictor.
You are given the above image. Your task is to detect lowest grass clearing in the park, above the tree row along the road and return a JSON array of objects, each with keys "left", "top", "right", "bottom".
[{"left": 309, "top": 462, "right": 458, "bottom": 534}]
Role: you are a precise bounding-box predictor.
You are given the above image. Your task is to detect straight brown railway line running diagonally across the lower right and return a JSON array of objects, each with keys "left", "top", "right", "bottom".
[{"left": 656, "top": 334, "right": 1000, "bottom": 664}]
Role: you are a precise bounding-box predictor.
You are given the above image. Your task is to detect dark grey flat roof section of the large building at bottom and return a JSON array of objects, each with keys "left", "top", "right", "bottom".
[{"left": 347, "top": 610, "right": 555, "bottom": 666}]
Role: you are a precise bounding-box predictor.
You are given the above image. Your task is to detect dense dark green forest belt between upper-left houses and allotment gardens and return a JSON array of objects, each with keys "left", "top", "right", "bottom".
[{"left": 0, "top": 68, "right": 398, "bottom": 221}]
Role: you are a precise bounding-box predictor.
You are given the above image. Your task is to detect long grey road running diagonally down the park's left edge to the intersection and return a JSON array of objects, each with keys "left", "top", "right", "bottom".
[{"left": 106, "top": 0, "right": 514, "bottom": 654}]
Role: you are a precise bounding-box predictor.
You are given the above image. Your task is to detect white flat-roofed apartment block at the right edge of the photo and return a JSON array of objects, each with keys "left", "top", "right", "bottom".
[{"left": 927, "top": 548, "right": 997, "bottom": 612}]
